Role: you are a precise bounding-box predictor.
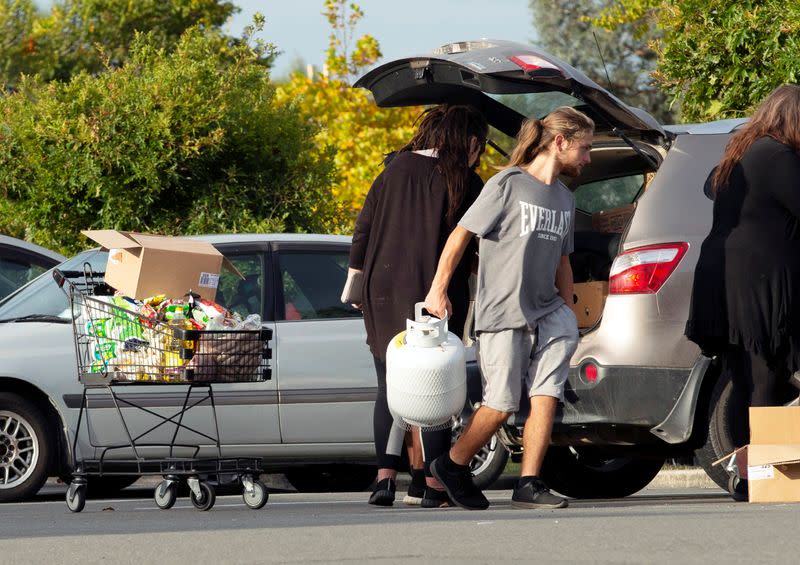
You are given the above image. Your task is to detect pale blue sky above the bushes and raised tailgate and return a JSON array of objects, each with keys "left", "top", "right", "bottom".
[{"left": 226, "top": 0, "right": 535, "bottom": 76}]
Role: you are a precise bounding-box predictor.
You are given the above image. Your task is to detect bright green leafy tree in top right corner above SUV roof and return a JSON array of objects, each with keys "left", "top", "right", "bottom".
[{"left": 597, "top": 0, "right": 800, "bottom": 121}]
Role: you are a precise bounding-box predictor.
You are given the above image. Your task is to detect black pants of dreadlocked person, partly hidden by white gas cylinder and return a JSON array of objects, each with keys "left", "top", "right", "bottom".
[{"left": 372, "top": 357, "right": 452, "bottom": 477}]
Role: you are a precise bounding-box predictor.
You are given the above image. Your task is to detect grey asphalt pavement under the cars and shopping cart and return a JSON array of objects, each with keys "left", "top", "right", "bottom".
[{"left": 0, "top": 476, "right": 800, "bottom": 564}]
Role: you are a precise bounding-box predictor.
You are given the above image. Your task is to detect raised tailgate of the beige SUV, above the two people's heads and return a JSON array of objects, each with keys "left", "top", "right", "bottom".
[{"left": 354, "top": 39, "right": 667, "bottom": 139}]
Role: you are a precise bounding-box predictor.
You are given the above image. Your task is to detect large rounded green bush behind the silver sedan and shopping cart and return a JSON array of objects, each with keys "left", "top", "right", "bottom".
[{"left": 0, "top": 24, "right": 341, "bottom": 252}]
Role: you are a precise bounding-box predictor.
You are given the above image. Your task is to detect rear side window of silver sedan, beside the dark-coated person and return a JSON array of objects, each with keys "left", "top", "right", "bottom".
[{"left": 279, "top": 250, "right": 361, "bottom": 320}]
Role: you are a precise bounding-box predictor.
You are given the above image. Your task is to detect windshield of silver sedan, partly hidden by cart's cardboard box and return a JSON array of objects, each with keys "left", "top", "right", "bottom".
[{"left": 0, "top": 249, "right": 108, "bottom": 321}]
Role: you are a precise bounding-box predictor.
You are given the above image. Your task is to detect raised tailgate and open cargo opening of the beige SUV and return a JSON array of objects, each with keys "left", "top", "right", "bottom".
[{"left": 355, "top": 39, "right": 671, "bottom": 331}]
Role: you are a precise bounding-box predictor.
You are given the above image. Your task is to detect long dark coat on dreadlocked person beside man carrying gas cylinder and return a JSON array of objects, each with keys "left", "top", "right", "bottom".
[{"left": 350, "top": 152, "right": 483, "bottom": 360}]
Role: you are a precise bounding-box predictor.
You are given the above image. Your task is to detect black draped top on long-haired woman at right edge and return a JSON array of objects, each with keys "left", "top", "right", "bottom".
[{"left": 687, "top": 137, "right": 800, "bottom": 371}]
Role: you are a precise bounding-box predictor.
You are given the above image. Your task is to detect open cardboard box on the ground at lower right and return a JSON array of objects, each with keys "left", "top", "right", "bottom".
[{"left": 714, "top": 406, "right": 800, "bottom": 502}]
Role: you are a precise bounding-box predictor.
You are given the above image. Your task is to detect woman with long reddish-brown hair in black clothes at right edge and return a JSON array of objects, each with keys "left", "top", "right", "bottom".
[{"left": 686, "top": 85, "right": 800, "bottom": 495}]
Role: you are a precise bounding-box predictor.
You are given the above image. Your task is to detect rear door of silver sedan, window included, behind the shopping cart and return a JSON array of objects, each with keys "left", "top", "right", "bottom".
[{"left": 273, "top": 243, "right": 377, "bottom": 443}]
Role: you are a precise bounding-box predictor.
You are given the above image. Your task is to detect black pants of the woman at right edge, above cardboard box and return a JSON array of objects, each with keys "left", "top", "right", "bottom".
[{"left": 721, "top": 346, "right": 797, "bottom": 447}]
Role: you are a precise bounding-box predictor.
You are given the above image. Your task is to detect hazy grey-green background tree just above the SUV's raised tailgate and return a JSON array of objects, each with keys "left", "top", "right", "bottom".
[{"left": 530, "top": 0, "right": 675, "bottom": 123}]
